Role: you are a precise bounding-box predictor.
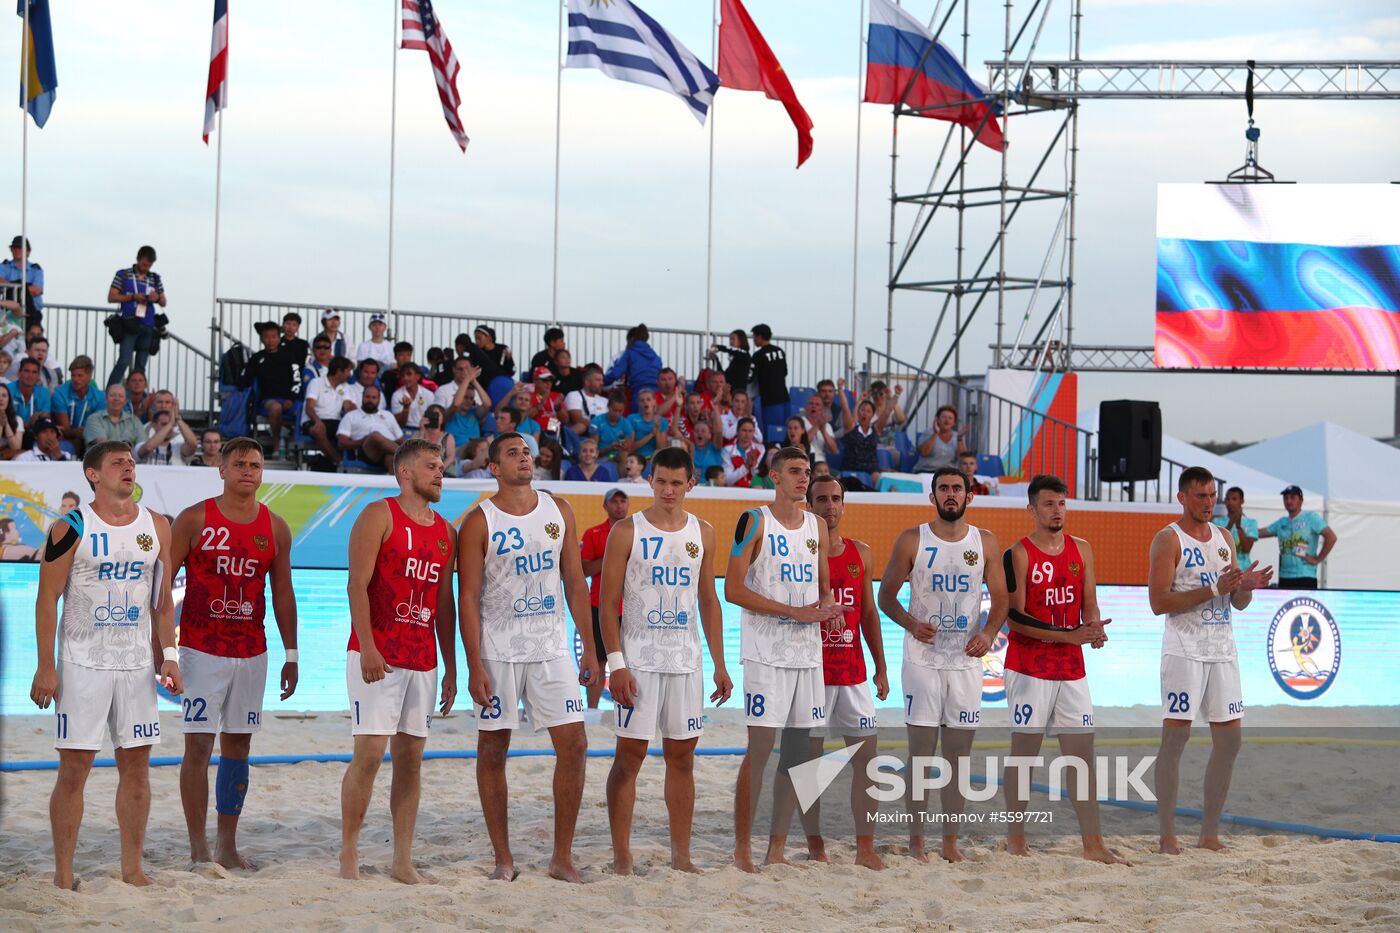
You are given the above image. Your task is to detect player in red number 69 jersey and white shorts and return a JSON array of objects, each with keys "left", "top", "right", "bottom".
[{"left": 1004, "top": 474, "right": 1128, "bottom": 864}]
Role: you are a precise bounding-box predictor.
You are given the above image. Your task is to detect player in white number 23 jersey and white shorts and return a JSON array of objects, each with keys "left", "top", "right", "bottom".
[{"left": 458, "top": 431, "right": 602, "bottom": 881}]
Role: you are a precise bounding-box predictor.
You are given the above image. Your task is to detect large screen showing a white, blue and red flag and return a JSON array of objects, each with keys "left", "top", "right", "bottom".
[{"left": 1155, "top": 185, "right": 1400, "bottom": 371}]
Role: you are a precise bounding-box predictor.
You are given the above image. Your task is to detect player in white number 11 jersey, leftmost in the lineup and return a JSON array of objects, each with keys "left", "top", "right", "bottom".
[{"left": 29, "top": 441, "right": 183, "bottom": 890}]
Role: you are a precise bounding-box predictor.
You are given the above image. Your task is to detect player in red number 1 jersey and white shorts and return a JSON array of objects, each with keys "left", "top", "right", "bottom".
[{"left": 340, "top": 438, "right": 456, "bottom": 884}]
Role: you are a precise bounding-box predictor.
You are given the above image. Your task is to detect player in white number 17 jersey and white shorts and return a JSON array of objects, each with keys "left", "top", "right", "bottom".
[{"left": 598, "top": 447, "right": 734, "bottom": 874}]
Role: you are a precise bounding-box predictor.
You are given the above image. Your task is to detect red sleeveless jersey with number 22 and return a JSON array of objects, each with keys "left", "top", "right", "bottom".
[{"left": 179, "top": 499, "right": 277, "bottom": 657}]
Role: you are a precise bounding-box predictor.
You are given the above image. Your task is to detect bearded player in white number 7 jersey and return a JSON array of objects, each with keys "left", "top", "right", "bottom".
[{"left": 879, "top": 467, "right": 1009, "bottom": 862}]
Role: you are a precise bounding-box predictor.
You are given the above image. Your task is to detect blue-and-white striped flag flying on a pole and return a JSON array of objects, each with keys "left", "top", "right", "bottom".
[{"left": 566, "top": 0, "right": 720, "bottom": 125}]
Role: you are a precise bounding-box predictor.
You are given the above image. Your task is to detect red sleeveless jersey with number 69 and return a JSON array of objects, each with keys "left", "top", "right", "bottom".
[{"left": 1005, "top": 535, "right": 1084, "bottom": 681}]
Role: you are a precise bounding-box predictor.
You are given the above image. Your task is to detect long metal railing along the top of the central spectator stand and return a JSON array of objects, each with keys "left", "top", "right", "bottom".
[{"left": 214, "top": 298, "right": 854, "bottom": 387}]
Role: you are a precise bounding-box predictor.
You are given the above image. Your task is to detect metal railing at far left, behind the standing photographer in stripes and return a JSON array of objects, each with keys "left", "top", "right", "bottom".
[{"left": 31, "top": 304, "right": 218, "bottom": 416}]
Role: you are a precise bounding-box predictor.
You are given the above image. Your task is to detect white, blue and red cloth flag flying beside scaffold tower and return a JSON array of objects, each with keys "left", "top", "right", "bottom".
[{"left": 865, "top": 0, "right": 1002, "bottom": 153}]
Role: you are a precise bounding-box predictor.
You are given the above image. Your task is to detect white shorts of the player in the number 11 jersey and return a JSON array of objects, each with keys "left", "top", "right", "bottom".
[{"left": 53, "top": 661, "right": 161, "bottom": 751}]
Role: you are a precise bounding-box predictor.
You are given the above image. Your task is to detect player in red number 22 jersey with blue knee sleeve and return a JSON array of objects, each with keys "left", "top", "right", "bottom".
[{"left": 171, "top": 437, "right": 298, "bottom": 869}]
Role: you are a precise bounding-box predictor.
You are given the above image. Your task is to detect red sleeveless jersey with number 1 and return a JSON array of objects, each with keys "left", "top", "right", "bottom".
[{"left": 349, "top": 496, "right": 452, "bottom": 671}]
